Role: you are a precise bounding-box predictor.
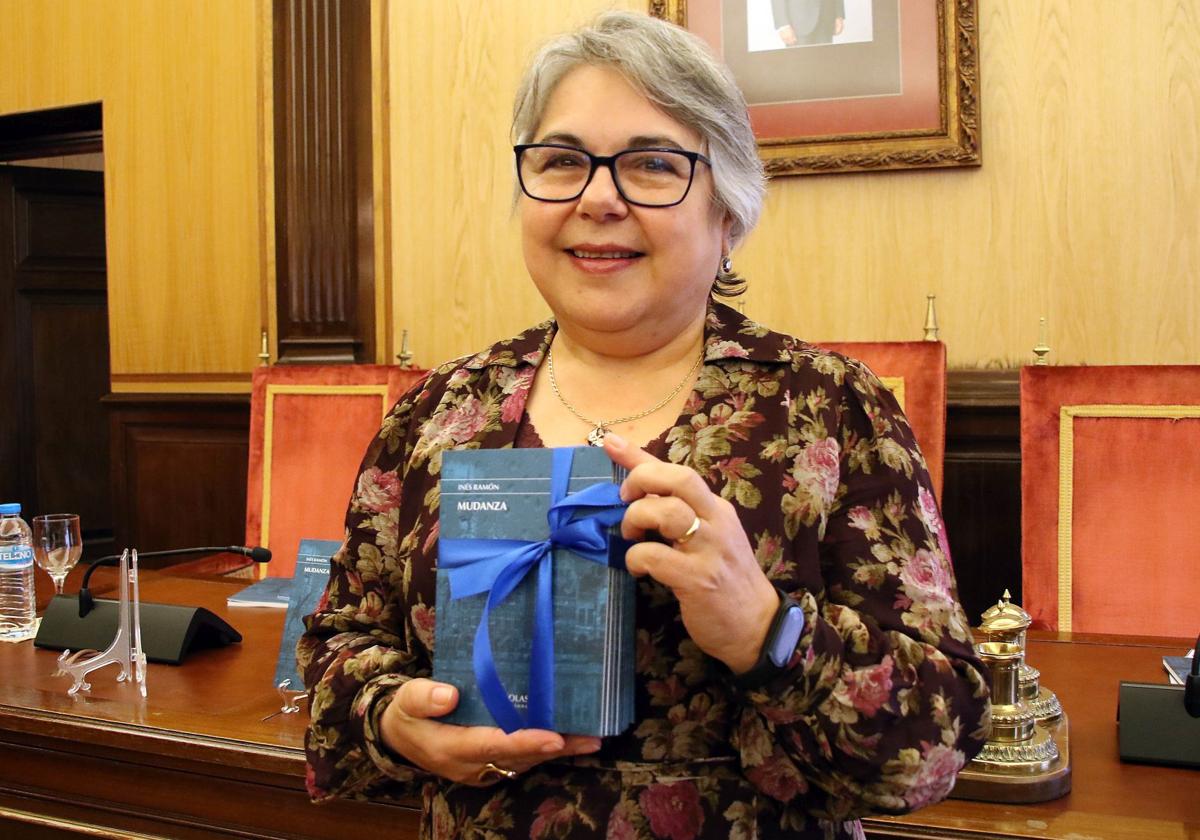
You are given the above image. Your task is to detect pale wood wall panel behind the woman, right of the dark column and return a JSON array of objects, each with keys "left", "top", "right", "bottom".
[{"left": 388, "top": 0, "right": 1200, "bottom": 368}]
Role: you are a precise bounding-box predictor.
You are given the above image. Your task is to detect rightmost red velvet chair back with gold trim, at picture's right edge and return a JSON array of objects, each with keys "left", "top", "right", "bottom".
[{"left": 1021, "top": 365, "right": 1200, "bottom": 638}]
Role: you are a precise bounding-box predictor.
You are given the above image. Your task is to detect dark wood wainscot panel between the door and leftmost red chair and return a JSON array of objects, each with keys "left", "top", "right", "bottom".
[{"left": 106, "top": 394, "right": 250, "bottom": 551}]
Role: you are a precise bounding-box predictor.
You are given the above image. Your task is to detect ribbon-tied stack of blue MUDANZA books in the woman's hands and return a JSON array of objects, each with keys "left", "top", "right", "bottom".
[{"left": 433, "top": 446, "right": 635, "bottom": 736}]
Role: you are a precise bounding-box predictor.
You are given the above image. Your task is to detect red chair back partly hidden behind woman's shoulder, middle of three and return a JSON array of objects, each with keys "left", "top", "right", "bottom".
[{"left": 816, "top": 341, "right": 946, "bottom": 502}]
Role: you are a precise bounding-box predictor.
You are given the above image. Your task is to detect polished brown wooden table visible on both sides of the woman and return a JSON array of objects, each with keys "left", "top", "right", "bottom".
[{"left": 0, "top": 571, "right": 1200, "bottom": 840}]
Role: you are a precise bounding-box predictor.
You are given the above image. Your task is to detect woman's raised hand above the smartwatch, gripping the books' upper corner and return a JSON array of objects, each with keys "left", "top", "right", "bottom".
[{"left": 604, "top": 432, "right": 779, "bottom": 673}]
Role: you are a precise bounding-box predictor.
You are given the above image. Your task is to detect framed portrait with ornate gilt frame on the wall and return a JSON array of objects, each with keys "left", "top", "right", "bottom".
[{"left": 650, "top": 0, "right": 980, "bottom": 176}]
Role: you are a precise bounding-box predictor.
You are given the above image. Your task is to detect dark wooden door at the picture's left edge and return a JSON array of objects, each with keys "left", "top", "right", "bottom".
[{"left": 0, "top": 166, "right": 113, "bottom": 557}]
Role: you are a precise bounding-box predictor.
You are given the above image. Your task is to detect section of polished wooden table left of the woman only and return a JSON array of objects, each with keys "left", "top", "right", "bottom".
[{"left": 0, "top": 570, "right": 418, "bottom": 838}]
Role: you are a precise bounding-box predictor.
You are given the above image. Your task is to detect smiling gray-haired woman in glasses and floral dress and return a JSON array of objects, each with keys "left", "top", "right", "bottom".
[{"left": 300, "top": 13, "right": 988, "bottom": 840}]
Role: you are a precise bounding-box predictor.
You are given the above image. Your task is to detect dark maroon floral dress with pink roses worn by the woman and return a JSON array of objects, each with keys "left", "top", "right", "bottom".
[{"left": 298, "top": 302, "right": 990, "bottom": 840}]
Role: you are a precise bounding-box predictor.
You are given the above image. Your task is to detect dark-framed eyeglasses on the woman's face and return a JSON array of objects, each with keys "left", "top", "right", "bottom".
[{"left": 512, "top": 143, "right": 713, "bottom": 208}]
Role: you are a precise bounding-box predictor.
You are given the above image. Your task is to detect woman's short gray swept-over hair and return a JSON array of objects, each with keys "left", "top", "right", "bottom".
[{"left": 512, "top": 12, "right": 766, "bottom": 294}]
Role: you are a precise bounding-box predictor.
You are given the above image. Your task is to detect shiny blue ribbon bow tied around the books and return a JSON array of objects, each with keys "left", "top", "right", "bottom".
[{"left": 438, "top": 448, "right": 626, "bottom": 732}]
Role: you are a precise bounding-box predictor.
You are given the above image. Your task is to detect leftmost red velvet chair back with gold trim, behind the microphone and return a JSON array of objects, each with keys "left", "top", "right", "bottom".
[{"left": 246, "top": 365, "right": 425, "bottom": 577}]
